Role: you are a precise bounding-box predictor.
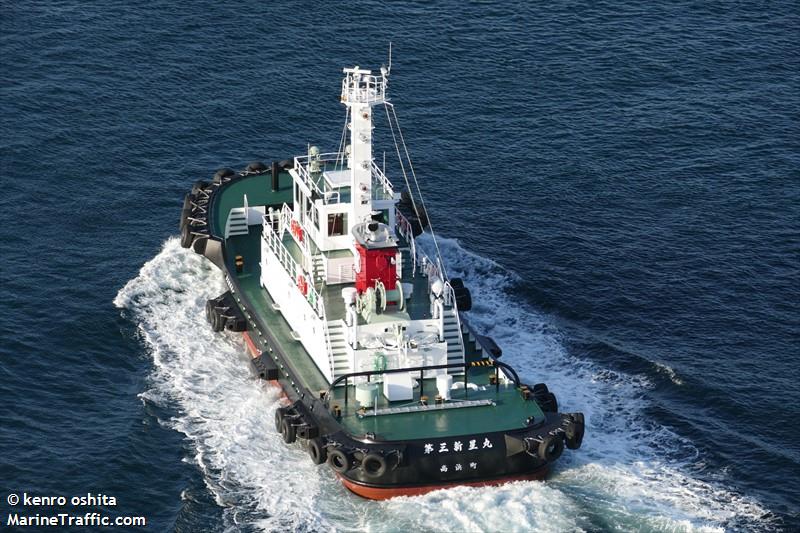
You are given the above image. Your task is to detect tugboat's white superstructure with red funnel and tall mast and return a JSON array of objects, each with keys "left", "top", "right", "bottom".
[{"left": 260, "top": 67, "right": 464, "bottom": 386}]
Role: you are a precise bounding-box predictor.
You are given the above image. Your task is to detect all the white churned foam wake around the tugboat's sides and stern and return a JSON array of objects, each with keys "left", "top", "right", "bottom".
[{"left": 114, "top": 238, "right": 765, "bottom": 532}]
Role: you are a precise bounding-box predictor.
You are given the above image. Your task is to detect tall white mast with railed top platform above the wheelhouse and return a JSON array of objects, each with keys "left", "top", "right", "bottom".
[{"left": 341, "top": 66, "right": 389, "bottom": 227}]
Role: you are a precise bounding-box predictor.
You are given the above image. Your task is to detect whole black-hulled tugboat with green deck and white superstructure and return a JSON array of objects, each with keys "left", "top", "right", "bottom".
[{"left": 180, "top": 62, "right": 584, "bottom": 499}]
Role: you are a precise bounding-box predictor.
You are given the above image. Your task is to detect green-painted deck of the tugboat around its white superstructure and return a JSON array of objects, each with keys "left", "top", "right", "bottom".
[{"left": 215, "top": 173, "right": 544, "bottom": 440}]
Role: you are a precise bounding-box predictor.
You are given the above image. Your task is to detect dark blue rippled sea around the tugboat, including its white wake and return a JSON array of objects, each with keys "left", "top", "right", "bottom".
[{"left": 0, "top": 0, "right": 800, "bottom": 532}]
